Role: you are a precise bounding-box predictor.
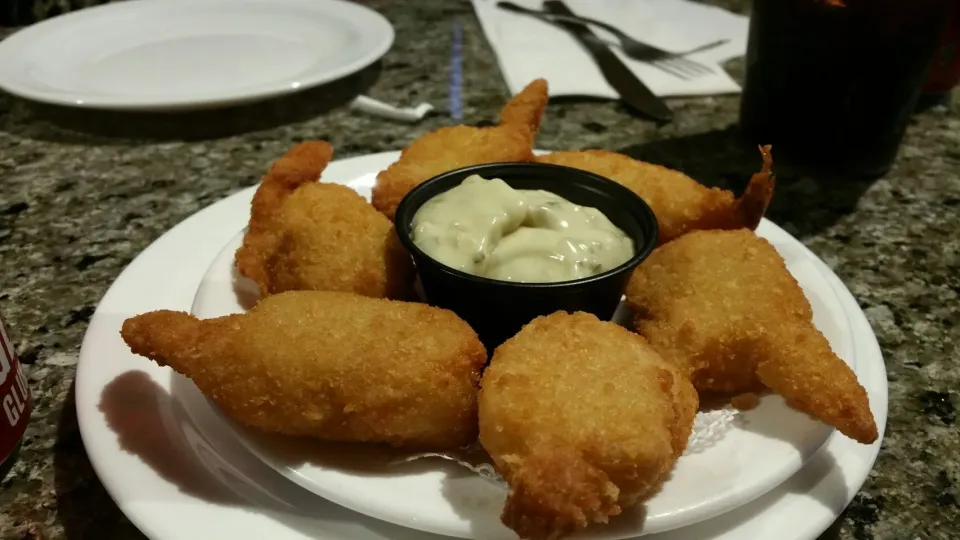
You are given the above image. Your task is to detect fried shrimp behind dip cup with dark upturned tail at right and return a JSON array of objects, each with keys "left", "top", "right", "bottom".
[{"left": 536, "top": 146, "right": 775, "bottom": 244}]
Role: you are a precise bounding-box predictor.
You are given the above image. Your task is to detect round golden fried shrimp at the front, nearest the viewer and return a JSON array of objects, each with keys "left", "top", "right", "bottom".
[{"left": 480, "top": 312, "right": 698, "bottom": 539}]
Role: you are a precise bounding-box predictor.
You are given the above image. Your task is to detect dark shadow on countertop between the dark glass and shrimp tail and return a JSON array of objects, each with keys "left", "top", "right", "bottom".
[{"left": 618, "top": 125, "right": 875, "bottom": 240}]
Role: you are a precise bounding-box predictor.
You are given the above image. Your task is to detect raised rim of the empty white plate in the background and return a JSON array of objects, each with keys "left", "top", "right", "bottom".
[{"left": 0, "top": 0, "right": 396, "bottom": 112}]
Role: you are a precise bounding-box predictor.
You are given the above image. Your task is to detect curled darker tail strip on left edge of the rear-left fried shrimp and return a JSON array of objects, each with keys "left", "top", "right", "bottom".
[{"left": 236, "top": 141, "right": 333, "bottom": 288}]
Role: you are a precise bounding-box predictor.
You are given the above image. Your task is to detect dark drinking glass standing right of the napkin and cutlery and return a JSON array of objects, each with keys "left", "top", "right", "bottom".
[{"left": 740, "top": 0, "right": 956, "bottom": 177}]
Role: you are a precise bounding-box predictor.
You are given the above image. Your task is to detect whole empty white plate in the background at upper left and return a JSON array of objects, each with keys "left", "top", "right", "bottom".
[{"left": 0, "top": 0, "right": 394, "bottom": 110}]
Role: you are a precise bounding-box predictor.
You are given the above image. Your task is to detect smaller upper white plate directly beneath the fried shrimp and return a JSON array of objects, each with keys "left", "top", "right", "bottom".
[{"left": 191, "top": 161, "right": 856, "bottom": 540}]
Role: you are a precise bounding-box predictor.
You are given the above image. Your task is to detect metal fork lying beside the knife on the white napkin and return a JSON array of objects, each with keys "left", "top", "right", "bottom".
[{"left": 497, "top": 2, "right": 729, "bottom": 80}]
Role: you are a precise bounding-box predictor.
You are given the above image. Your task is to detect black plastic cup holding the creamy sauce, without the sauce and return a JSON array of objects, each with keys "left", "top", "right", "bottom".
[{"left": 394, "top": 163, "right": 658, "bottom": 353}]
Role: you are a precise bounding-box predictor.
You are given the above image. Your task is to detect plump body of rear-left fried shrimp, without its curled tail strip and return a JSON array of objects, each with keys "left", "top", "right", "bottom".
[{"left": 236, "top": 143, "right": 414, "bottom": 299}]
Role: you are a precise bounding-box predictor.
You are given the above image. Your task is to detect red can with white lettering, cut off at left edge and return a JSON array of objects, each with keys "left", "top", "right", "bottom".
[{"left": 0, "top": 312, "right": 33, "bottom": 473}]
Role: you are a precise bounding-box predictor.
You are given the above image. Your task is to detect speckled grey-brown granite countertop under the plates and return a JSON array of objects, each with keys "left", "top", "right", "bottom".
[{"left": 0, "top": 0, "right": 960, "bottom": 540}]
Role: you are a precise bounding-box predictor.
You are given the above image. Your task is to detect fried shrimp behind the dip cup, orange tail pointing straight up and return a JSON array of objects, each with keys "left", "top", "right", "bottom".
[{"left": 373, "top": 79, "right": 547, "bottom": 220}]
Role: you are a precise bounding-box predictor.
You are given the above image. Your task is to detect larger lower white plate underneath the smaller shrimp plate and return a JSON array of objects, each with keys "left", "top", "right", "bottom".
[{"left": 76, "top": 153, "right": 887, "bottom": 540}]
